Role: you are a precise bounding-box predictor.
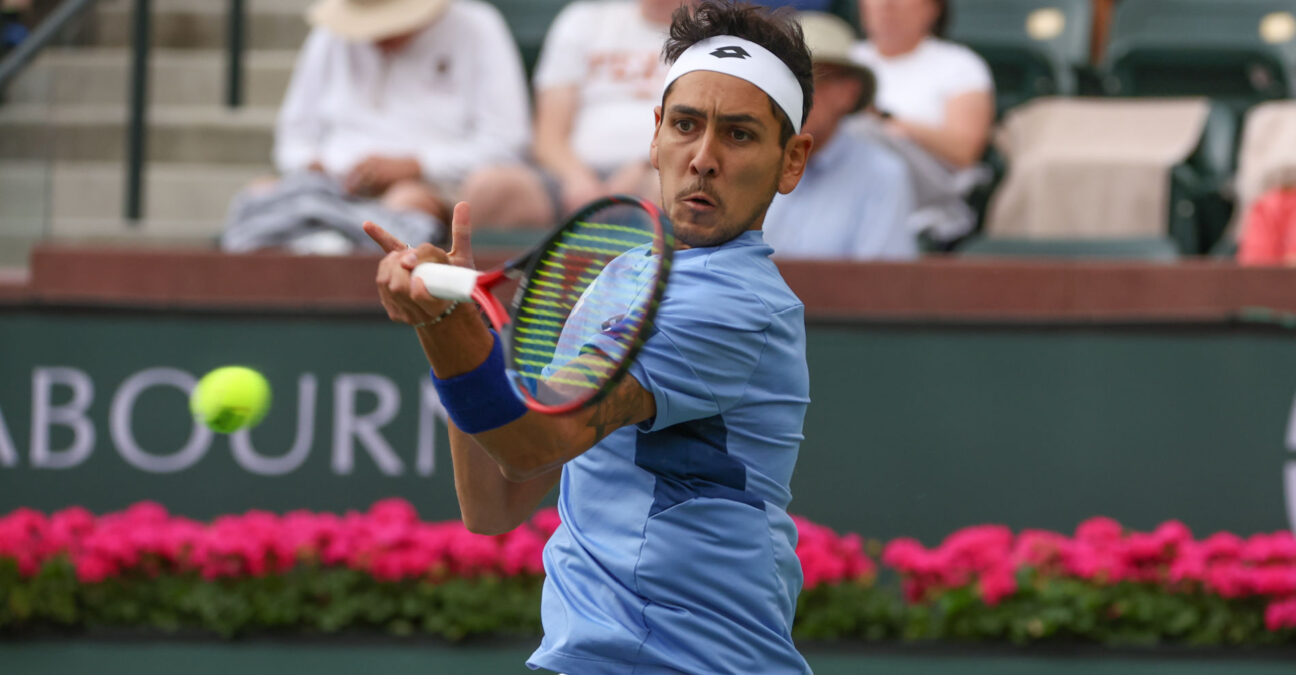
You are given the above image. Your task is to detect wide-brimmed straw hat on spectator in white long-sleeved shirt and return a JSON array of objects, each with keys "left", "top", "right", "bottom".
[{"left": 306, "top": 0, "right": 451, "bottom": 41}]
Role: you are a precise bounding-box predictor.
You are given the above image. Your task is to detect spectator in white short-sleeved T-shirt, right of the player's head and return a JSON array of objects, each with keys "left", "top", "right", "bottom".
[{"left": 854, "top": 0, "right": 994, "bottom": 168}]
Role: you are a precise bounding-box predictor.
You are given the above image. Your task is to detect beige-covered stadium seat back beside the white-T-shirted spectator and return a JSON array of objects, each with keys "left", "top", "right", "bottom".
[{"left": 984, "top": 98, "right": 1236, "bottom": 254}]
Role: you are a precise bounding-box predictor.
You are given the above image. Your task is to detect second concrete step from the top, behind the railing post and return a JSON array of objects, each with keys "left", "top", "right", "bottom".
[{"left": 6, "top": 48, "right": 297, "bottom": 108}]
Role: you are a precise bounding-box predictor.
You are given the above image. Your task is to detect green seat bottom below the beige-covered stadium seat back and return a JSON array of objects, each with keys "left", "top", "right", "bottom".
[{"left": 958, "top": 236, "right": 1179, "bottom": 263}]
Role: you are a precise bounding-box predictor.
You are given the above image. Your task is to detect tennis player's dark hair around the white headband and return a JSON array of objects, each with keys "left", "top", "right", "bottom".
[{"left": 662, "top": 0, "right": 814, "bottom": 145}]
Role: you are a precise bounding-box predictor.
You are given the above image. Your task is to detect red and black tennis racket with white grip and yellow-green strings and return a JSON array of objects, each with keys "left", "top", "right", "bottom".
[{"left": 413, "top": 196, "right": 675, "bottom": 415}]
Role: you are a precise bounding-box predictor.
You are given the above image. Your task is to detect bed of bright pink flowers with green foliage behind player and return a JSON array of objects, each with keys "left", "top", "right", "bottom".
[{"left": 0, "top": 500, "right": 1296, "bottom": 645}]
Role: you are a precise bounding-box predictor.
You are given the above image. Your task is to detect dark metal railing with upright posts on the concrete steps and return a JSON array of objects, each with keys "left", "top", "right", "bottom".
[{"left": 0, "top": 0, "right": 248, "bottom": 224}]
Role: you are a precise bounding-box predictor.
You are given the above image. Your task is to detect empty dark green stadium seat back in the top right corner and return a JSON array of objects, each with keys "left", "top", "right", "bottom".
[{"left": 1104, "top": 0, "right": 1296, "bottom": 113}]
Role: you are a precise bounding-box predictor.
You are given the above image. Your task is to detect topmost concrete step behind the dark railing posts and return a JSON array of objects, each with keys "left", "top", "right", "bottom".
[{"left": 86, "top": 0, "right": 311, "bottom": 49}]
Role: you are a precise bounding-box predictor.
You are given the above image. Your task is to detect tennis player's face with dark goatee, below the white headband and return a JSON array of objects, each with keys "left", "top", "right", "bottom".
[{"left": 651, "top": 70, "right": 810, "bottom": 247}]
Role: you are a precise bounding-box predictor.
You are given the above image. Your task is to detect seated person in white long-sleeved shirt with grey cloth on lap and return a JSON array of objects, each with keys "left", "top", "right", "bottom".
[{"left": 223, "top": 0, "right": 530, "bottom": 253}]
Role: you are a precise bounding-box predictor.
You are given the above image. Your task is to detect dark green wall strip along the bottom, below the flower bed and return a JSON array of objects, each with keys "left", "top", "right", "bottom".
[{"left": 0, "top": 641, "right": 1291, "bottom": 675}]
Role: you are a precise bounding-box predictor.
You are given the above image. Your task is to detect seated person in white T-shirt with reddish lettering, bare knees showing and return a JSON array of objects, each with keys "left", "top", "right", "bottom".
[{"left": 464, "top": 0, "right": 688, "bottom": 227}]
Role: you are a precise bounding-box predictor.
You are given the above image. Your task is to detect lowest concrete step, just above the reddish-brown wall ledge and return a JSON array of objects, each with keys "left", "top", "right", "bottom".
[{"left": 0, "top": 162, "right": 270, "bottom": 240}]
